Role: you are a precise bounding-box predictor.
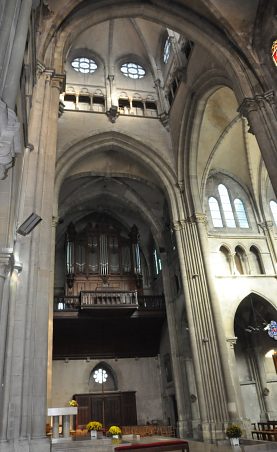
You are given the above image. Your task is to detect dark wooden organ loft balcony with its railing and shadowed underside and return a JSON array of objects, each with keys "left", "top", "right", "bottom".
[{"left": 53, "top": 291, "right": 166, "bottom": 359}]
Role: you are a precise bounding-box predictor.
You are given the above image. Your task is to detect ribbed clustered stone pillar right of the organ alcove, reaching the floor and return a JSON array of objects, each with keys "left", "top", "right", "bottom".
[{"left": 171, "top": 215, "right": 238, "bottom": 440}]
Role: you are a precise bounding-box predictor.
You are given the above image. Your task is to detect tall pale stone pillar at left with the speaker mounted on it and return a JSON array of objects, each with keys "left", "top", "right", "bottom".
[{"left": 1, "top": 70, "right": 64, "bottom": 452}]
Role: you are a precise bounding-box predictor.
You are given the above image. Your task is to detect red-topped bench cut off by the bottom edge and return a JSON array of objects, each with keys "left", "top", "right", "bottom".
[{"left": 114, "top": 439, "right": 189, "bottom": 452}]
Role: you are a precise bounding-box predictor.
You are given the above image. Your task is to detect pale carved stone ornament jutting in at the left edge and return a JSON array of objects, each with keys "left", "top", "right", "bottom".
[{"left": 0, "top": 100, "right": 21, "bottom": 179}]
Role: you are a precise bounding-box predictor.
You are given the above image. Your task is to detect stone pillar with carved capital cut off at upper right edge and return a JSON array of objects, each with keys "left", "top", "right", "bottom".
[{"left": 238, "top": 91, "right": 277, "bottom": 195}]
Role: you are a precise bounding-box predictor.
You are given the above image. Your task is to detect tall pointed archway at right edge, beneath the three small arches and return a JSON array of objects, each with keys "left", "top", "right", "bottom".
[{"left": 234, "top": 293, "right": 277, "bottom": 423}]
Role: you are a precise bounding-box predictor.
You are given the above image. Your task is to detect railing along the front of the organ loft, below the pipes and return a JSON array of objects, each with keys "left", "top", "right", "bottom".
[{"left": 54, "top": 291, "right": 165, "bottom": 312}]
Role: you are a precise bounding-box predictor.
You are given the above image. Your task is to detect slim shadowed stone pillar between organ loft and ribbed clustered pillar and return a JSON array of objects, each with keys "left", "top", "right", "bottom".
[{"left": 161, "top": 253, "right": 191, "bottom": 437}]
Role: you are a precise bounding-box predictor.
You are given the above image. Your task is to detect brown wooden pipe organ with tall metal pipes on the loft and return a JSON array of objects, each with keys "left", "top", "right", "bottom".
[{"left": 65, "top": 222, "right": 142, "bottom": 295}]
